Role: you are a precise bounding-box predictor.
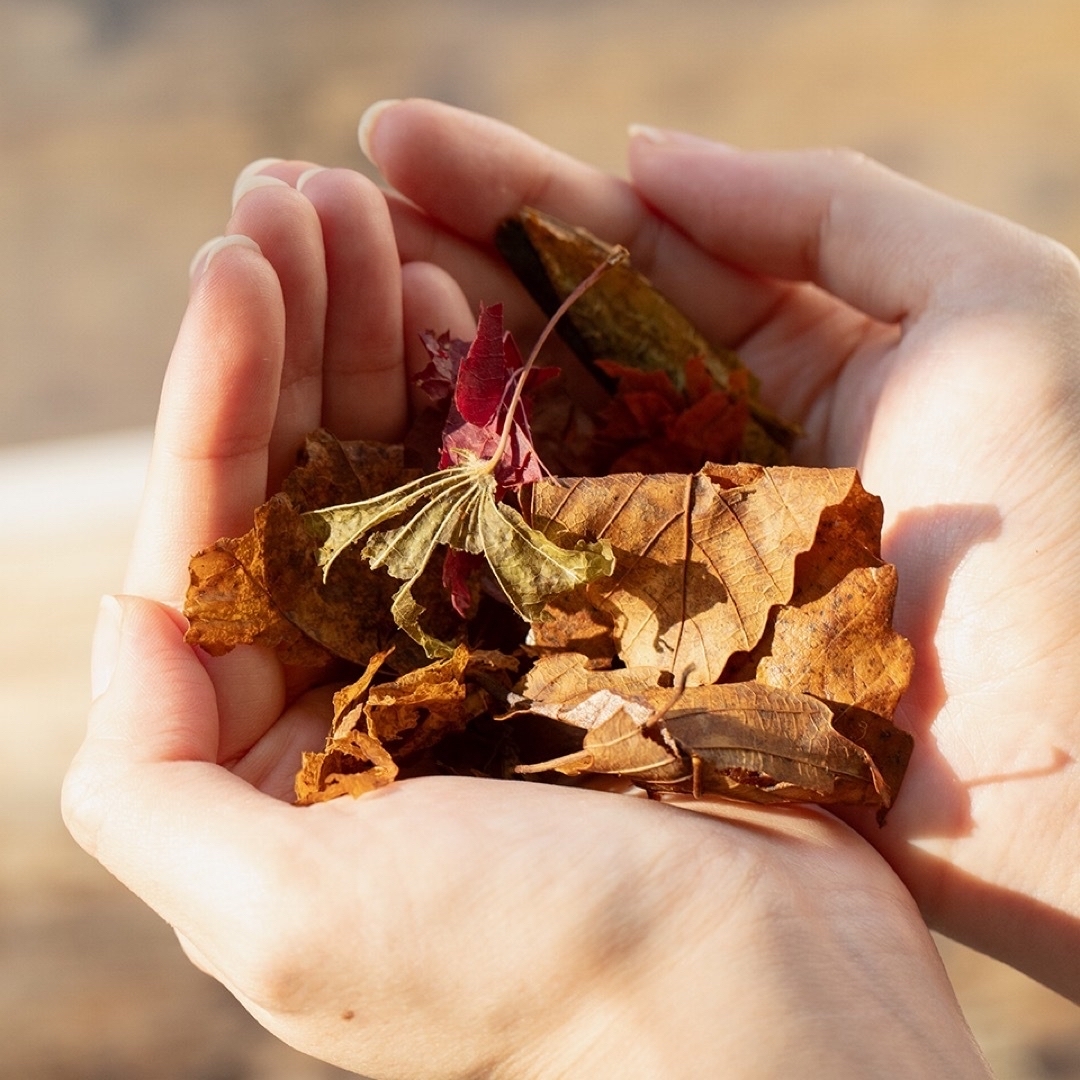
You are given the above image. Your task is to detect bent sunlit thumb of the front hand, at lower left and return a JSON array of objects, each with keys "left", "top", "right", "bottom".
[{"left": 62, "top": 596, "right": 291, "bottom": 953}]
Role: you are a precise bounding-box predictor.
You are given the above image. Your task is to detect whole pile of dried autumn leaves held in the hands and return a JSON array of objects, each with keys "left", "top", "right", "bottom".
[{"left": 186, "top": 211, "right": 913, "bottom": 814}]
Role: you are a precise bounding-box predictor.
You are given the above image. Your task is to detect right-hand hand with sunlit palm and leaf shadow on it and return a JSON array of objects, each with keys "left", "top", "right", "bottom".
[{"left": 361, "top": 102, "right": 1080, "bottom": 1000}]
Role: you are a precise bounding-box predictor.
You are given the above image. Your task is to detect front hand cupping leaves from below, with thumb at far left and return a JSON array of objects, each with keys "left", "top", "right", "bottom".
[{"left": 64, "top": 156, "right": 986, "bottom": 1080}]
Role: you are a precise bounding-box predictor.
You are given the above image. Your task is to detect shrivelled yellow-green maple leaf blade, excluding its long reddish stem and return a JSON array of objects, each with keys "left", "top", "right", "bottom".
[{"left": 309, "top": 461, "right": 613, "bottom": 657}]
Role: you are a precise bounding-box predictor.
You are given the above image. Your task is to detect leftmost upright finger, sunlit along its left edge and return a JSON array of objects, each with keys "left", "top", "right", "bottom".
[{"left": 125, "top": 235, "right": 285, "bottom": 606}]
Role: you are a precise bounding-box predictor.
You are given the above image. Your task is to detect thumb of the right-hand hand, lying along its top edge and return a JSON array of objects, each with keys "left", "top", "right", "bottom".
[{"left": 630, "top": 127, "right": 1009, "bottom": 323}]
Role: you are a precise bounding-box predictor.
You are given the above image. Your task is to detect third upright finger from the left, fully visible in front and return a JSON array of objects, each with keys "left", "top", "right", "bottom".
[{"left": 296, "top": 168, "right": 407, "bottom": 441}]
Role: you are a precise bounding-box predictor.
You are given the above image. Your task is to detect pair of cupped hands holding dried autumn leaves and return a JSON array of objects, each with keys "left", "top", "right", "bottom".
[{"left": 64, "top": 100, "right": 1080, "bottom": 1080}]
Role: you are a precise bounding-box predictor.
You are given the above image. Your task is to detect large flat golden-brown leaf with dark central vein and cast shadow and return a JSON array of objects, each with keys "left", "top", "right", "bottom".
[{"left": 529, "top": 465, "right": 862, "bottom": 686}]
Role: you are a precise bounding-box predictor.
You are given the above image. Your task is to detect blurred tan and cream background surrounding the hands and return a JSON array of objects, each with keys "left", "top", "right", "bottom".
[{"left": 0, "top": 0, "right": 1080, "bottom": 1080}]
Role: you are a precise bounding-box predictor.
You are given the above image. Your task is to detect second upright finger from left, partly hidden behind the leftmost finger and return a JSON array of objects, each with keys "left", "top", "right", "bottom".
[{"left": 227, "top": 176, "right": 327, "bottom": 487}]
